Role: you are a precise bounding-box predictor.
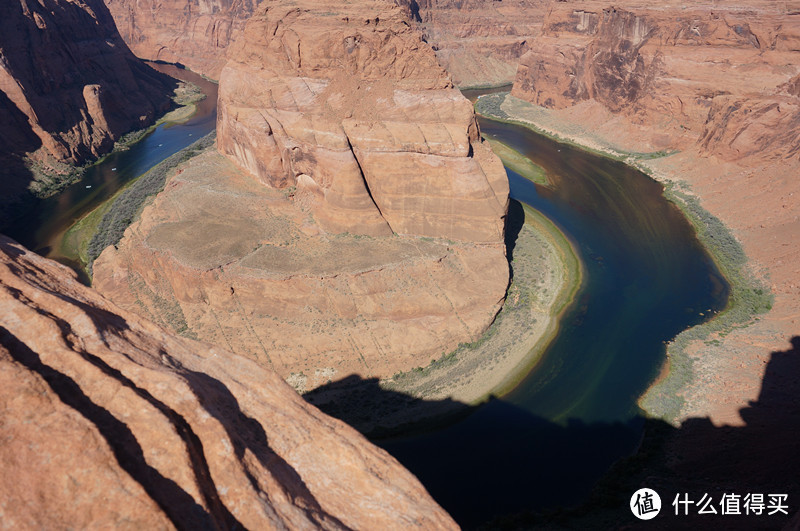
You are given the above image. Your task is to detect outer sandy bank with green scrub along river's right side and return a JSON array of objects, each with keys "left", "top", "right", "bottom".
[{"left": 478, "top": 95, "right": 800, "bottom": 425}]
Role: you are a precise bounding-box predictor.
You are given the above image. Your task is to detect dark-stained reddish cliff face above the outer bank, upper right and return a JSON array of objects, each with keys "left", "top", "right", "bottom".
[{"left": 513, "top": 2, "right": 800, "bottom": 158}]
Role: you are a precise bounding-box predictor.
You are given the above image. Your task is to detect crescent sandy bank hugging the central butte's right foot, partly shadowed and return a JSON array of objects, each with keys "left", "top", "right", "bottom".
[{"left": 305, "top": 202, "right": 582, "bottom": 434}]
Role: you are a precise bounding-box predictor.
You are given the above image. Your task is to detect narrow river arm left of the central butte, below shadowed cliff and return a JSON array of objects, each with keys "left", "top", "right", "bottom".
[{"left": 4, "top": 64, "right": 217, "bottom": 268}]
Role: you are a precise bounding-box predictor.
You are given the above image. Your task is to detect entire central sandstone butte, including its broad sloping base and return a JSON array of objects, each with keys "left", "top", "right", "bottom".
[{"left": 93, "top": 0, "right": 509, "bottom": 390}]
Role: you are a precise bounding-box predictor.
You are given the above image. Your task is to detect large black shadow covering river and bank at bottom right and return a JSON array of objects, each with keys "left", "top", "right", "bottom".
[{"left": 305, "top": 336, "right": 800, "bottom": 529}]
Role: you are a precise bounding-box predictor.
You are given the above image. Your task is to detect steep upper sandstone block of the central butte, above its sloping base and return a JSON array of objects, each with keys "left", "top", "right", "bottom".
[{"left": 217, "top": 0, "right": 508, "bottom": 244}]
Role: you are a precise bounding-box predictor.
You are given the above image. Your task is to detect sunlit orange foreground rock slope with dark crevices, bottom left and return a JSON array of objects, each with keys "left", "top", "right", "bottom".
[{"left": 0, "top": 237, "right": 456, "bottom": 529}]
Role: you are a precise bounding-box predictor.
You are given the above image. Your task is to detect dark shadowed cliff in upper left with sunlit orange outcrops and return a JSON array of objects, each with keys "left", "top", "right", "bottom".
[{"left": 0, "top": 0, "right": 175, "bottom": 186}]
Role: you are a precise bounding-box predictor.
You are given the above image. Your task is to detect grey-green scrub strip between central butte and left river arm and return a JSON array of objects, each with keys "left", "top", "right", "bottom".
[{"left": 86, "top": 132, "right": 217, "bottom": 274}]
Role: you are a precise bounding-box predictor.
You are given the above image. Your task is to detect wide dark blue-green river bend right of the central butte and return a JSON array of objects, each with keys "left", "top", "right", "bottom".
[{"left": 379, "top": 104, "right": 728, "bottom": 526}]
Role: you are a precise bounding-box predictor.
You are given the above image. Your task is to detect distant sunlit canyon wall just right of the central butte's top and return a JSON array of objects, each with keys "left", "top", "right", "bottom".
[{"left": 395, "top": 0, "right": 548, "bottom": 86}]
